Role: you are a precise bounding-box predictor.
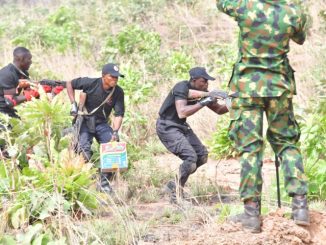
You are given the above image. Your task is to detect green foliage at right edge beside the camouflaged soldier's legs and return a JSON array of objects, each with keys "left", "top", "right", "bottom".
[{"left": 301, "top": 47, "right": 326, "bottom": 200}]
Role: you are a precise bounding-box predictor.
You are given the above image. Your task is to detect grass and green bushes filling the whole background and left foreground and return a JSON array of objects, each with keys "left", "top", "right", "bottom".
[{"left": 0, "top": 0, "right": 326, "bottom": 244}]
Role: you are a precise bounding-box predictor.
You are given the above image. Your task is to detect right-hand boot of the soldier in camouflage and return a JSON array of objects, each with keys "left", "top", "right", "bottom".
[{"left": 292, "top": 195, "right": 310, "bottom": 226}]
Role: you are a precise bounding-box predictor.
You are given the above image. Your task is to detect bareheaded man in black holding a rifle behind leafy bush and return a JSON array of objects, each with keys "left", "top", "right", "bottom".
[{"left": 0, "top": 47, "right": 39, "bottom": 118}]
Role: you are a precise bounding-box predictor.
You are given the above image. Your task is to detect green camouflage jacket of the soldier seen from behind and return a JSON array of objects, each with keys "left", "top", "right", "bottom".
[{"left": 217, "top": 0, "right": 306, "bottom": 98}]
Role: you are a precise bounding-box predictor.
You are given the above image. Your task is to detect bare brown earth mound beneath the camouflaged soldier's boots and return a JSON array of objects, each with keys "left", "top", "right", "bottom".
[{"left": 140, "top": 210, "right": 326, "bottom": 245}]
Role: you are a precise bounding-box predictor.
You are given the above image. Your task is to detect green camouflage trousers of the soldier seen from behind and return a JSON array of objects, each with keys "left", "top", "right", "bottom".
[{"left": 229, "top": 95, "right": 307, "bottom": 201}]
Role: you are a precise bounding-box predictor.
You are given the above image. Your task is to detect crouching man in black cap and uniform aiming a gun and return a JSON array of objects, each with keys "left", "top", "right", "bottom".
[{"left": 156, "top": 67, "right": 228, "bottom": 203}]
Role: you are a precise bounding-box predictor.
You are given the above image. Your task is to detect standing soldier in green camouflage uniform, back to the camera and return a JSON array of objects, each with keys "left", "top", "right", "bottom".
[{"left": 217, "top": 0, "right": 309, "bottom": 232}]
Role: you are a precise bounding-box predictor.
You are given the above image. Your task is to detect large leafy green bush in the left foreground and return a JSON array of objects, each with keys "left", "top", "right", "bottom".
[{"left": 0, "top": 96, "right": 98, "bottom": 241}]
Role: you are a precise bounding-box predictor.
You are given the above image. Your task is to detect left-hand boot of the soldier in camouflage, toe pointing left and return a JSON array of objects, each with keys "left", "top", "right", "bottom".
[{"left": 228, "top": 203, "right": 261, "bottom": 233}]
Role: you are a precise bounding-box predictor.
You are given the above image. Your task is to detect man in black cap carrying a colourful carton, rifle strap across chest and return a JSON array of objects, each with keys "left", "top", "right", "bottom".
[{"left": 66, "top": 63, "right": 125, "bottom": 192}]
